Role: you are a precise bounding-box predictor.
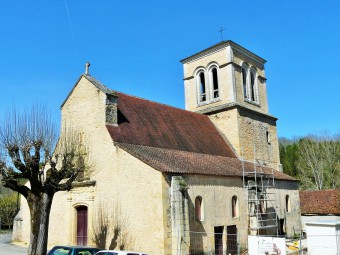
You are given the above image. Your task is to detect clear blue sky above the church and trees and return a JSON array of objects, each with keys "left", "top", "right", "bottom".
[{"left": 0, "top": 0, "right": 340, "bottom": 137}]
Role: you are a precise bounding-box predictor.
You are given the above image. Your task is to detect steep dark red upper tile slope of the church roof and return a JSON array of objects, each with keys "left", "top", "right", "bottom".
[{"left": 107, "top": 92, "right": 236, "bottom": 158}]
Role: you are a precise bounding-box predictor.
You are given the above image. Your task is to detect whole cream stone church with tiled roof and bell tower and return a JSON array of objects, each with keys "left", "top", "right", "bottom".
[{"left": 13, "top": 41, "right": 300, "bottom": 255}]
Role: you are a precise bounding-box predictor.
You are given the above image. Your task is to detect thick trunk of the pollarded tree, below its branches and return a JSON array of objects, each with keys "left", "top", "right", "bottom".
[{"left": 27, "top": 193, "right": 54, "bottom": 255}]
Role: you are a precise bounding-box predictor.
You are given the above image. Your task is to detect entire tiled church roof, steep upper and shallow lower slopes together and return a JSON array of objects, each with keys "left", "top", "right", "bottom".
[{"left": 82, "top": 76, "right": 295, "bottom": 181}]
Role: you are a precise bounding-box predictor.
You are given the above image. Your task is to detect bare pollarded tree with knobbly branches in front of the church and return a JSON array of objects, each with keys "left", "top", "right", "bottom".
[{"left": 0, "top": 106, "right": 86, "bottom": 255}]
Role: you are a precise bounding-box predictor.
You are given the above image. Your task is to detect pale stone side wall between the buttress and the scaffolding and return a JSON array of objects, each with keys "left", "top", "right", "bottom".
[{"left": 183, "top": 175, "right": 248, "bottom": 252}]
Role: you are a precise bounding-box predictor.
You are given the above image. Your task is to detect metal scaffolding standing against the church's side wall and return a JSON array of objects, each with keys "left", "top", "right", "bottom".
[{"left": 242, "top": 154, "right": 279, "bottom": 236}]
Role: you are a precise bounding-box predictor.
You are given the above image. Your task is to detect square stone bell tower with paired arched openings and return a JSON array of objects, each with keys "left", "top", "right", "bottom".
[{"left": 181, "top": 41, "right": 280, "bottom": 170}]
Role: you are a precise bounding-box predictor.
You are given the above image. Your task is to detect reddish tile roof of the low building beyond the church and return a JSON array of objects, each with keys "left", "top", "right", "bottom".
[{"left": 300, "top": 189, "right": 340, "bottom": 215}]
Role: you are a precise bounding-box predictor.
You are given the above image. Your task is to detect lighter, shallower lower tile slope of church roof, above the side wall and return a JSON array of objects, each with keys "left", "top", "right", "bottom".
[{"left": 116, "top": 143, "right": 295, "bottom": 181}]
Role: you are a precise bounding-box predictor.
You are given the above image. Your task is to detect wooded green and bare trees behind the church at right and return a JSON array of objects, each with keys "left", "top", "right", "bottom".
[{"left": 279, "top": 134, "right": 340, "bottom": 190}]
